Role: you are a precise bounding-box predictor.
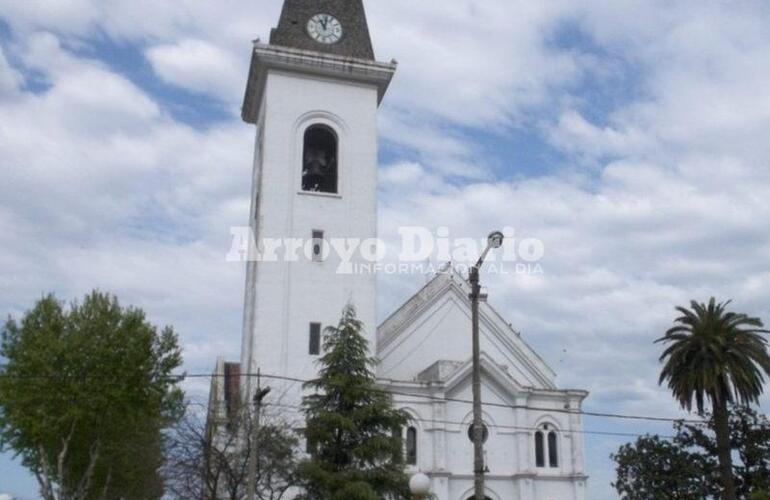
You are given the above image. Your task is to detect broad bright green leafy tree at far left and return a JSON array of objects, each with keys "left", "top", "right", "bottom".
[{"left": 0, "top": 291, "right": 182, "bottom": 500}]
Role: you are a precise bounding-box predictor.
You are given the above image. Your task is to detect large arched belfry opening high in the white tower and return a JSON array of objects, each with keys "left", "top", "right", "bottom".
[{"left": 302, "top": 125, "right": 338, "bottom": 193}]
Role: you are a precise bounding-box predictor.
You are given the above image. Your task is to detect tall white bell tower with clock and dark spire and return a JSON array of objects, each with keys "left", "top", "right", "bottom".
[{"left": 241, "top": 0, "right": 396, "bottom": 406}]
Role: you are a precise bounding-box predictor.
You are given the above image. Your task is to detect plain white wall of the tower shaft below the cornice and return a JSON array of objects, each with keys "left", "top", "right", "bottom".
[{"left": 242, "top": 70, "right": 378, "bottom": 405}]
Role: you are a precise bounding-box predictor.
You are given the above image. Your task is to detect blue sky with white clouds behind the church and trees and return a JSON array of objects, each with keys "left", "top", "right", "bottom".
[{"left": 0, "top": 0, "right": 770, "bottom": 500}]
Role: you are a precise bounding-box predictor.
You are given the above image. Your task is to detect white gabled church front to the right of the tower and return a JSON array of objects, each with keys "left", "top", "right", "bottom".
[{"left": 377, "top": 268, "right": 588, "bottom": 500}]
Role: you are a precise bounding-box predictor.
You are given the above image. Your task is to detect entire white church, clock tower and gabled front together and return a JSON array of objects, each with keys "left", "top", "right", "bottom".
[{"left": 210, "top": 0, "right": 587, "bottom": 500}]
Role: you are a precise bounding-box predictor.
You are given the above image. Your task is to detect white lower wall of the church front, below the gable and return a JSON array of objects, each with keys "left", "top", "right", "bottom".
[{"left": 384, "top": 377, "right": 587, "bottom": 500}]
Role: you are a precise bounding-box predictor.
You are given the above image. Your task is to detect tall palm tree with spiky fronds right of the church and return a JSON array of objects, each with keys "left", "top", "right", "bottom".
[{"left": 655, "top": 297, "right": 770, "bottom": 500}]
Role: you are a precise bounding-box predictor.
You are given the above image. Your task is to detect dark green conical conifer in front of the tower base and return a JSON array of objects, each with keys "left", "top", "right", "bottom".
[{"left": 300, "top": 305, "right": 409, "bottom": 500}]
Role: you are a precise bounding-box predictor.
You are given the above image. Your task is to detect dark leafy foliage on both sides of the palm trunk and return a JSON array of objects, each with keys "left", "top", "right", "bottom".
[{"left": 611, "top": 406, "right": 770, "bottom": 500}]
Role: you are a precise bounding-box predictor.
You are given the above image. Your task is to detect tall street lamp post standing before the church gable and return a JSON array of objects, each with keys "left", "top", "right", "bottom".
[{"left": 468, "top": 231, "right": 503, "bottom": 500}]
